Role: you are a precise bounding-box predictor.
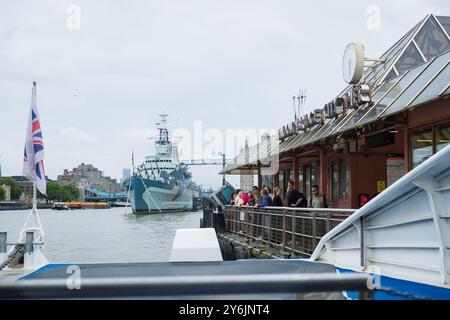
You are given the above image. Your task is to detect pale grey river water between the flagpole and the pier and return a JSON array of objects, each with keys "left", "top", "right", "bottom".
[{"left": 0, "top": 208, "right": 202, "bottom": 263}]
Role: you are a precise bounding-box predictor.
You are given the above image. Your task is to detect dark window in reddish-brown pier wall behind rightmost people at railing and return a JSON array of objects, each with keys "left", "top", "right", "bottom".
[{"left": 330, "top": 159, "right": 350, "bottom": 202}]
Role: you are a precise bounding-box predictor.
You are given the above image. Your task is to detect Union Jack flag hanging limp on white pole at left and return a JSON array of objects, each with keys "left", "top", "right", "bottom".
[{"left": 23, "top": 82, "right": 47, "bottom": 194}]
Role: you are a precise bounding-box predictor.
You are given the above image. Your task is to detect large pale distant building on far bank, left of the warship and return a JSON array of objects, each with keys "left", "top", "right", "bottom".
[{"left": 57, "top": 163, "right": 123, "bottom": 195}]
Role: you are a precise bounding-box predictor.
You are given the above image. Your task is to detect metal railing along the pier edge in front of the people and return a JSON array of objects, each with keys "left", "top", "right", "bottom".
[{"left": 225, "top": 206, "right": 356, "bottom": 257}]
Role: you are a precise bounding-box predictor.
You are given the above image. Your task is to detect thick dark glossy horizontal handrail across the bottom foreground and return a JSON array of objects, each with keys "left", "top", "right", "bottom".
[{"left": 0, "top": 273, "right": 371, "bottom": 299}]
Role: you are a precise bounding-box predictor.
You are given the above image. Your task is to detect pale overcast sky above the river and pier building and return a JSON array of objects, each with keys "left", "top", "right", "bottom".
[{"left": 0, "top": 0, "right": 450, "bottom": 187}]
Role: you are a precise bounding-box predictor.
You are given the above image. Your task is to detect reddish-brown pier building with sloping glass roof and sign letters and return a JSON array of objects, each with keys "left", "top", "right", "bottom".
[{"left": 220, "top": 14, "right": 450, "bottom": 208}]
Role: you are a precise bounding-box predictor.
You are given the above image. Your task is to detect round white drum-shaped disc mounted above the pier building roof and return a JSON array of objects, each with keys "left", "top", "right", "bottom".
[{"left": 342, "top": 42, "right": 364, "bottom": 84}]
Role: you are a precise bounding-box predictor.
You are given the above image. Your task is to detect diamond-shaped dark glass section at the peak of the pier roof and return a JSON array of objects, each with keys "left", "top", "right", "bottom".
[{"left": 415, "top": 17, "right": 450, "bottom": 60}]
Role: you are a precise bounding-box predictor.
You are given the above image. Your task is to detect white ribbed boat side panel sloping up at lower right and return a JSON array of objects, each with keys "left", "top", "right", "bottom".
[{"left": 311, "top": 145, "right": 450, "bottom": 287}]
